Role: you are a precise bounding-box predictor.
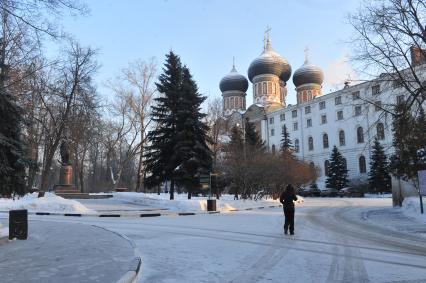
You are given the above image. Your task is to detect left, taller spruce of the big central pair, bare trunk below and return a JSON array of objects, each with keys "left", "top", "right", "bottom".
[{"left": 145, "top": 51, "right": 182, "bottom": 199}]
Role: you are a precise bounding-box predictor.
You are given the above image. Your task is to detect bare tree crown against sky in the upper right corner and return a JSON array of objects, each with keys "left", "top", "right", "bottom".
[{"left": 349, "top": 0, "right": 426, "bottom": 115}]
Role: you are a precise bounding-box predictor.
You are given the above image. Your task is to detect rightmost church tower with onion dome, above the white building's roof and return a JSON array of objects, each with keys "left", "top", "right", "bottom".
[{"left": 293, "top": 49, "right": 324, "bottom": 104}]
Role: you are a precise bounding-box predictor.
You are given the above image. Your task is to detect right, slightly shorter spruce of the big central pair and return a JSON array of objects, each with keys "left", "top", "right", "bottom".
[{"left": 173, "top": 66, "right": 212, "bottom": 199}]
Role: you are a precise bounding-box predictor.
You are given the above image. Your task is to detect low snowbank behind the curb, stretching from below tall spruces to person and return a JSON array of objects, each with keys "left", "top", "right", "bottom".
[{"left": 108, "top": 192, "right": 304, "bottom": 212}]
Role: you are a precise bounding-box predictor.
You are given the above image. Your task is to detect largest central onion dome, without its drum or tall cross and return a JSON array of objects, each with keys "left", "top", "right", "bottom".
[{"left": 248, "top": 39, "right": 291, "bottom": 82}]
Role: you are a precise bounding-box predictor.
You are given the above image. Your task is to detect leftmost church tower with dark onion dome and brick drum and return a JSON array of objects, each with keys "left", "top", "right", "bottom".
[{"left": 219, "top": 63, "right": 248, "bottom": 116}]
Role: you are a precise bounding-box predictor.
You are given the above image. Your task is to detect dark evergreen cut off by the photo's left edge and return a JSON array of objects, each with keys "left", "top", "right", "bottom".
[{"left": 0, "top": 63, "right": 28, "bottom": 197}]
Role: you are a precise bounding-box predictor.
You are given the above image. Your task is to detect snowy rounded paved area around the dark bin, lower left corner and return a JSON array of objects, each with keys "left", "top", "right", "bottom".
[{"left": 0, "top": 219, "right": 135, "bottom": 283}]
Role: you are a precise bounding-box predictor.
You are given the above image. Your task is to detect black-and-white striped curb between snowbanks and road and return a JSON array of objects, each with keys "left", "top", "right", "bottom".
[{"left": 0, "top": 204, "right": 282, "bottom": 218}]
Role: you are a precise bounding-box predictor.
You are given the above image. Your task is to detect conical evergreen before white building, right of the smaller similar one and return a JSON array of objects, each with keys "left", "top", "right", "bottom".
[{"left": 368, "top": 138, "right": 391, "bottom": 193}]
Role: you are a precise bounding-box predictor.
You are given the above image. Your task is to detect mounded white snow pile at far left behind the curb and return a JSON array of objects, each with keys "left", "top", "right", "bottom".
[{"left": 0, "top": 192, "right": 94, "bottom": 213}]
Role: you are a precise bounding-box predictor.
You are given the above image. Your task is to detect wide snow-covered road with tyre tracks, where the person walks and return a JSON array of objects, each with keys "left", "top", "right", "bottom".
[{"left": 25, "top": 198, "right": 426, "bottom": 283}]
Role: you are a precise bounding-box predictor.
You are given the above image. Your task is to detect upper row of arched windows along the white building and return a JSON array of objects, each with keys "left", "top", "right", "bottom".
[{"left": 271, "top": 123, "right": 385, "bottom": 152}]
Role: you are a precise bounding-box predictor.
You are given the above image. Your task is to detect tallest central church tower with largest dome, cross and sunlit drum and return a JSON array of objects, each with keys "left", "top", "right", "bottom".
[{"left": 248, "top": 28, "right": 291, "bottom": 106}]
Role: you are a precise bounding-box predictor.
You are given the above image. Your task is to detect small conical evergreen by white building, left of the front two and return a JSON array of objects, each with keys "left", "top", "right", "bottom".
[{"left": 325, "top": 146, "right": 348, "bottom": 190}]
